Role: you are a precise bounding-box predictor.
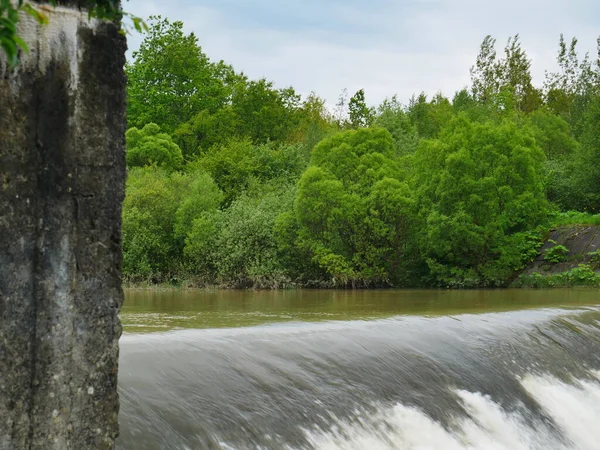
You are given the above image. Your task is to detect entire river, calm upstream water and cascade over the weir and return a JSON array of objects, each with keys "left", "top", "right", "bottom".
[{"left": 118, "top": 290, "right": 600, "bottom": 450}]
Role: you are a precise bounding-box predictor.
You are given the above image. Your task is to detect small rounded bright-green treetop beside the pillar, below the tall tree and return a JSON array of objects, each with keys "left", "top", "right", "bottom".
[{"left": 125, "top": 123, "right": 183, "bottom": 170}]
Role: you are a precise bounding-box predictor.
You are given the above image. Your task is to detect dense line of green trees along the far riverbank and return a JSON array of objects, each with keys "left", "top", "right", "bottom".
[{"left": 123, "top": 17, "right": 600, "bottom": 288}]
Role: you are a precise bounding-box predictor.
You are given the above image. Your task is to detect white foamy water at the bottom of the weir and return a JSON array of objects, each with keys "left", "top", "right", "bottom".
[{"left": 307, "top": 376, "right": 600, "bottom": 450}]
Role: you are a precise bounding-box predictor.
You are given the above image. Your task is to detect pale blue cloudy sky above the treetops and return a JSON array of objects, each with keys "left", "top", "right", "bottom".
[{"left": 124, "top": 0, "right": 600, "bottom": 106}]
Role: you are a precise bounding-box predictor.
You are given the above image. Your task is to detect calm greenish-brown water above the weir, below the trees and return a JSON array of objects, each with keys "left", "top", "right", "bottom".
[{"left": 121, "top": 289, "right": 600, "bottom": 333}]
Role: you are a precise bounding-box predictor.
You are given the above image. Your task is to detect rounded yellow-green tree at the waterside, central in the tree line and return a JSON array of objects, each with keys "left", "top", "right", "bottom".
[{"left": 295, "top": 128, "right": 412, "bottom": 285}]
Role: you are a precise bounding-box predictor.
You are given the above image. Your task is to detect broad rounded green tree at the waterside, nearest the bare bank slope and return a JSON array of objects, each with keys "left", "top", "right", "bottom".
[{"left": 413, "top": 116, "right": 547, "bottom": 286}]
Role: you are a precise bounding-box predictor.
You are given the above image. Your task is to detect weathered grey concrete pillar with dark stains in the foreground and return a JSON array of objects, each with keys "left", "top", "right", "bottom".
[{"left": 0, "top": 1, "right": 126, "bottom": 450}]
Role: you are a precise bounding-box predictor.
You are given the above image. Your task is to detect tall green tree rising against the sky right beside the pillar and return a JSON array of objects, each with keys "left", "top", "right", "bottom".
[{"left": 125, "top": 16, "right": 235, "bottom": 133}]
